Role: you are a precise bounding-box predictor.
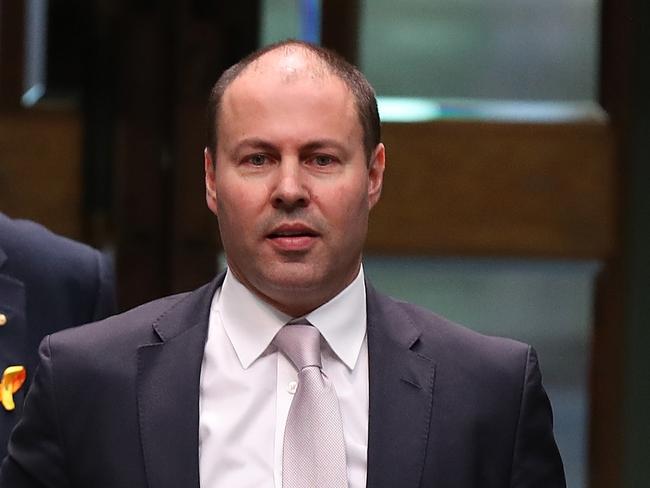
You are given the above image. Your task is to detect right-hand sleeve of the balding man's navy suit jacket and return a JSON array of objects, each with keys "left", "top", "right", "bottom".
[{"left": 510, "top": 347, "right": 566, "bottom": 488}]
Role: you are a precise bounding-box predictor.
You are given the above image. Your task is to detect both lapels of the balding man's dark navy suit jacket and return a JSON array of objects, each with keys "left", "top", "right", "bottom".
[{"left": 138, "top": 275, "right": 435, "bottom": 488}]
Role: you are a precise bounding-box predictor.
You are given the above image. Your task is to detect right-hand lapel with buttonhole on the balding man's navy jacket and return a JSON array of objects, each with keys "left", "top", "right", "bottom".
[{"left": 366, "top": 284, "right": 435, "bottom": 488}]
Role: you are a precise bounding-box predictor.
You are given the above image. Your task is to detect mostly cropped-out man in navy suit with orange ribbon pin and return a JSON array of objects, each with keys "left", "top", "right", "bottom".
[{"left": 0, "top": 212, "right": 115, "bottom": 457}]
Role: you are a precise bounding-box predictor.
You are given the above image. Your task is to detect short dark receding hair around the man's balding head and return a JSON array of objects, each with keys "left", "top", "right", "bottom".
[{"left": 207, "top": 39, "right": 381, "bottom": 159}]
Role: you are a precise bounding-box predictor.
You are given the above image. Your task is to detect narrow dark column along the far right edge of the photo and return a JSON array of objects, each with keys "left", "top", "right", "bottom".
[{"left": 622, "top": 0, "right": 650, "bottom": 488}]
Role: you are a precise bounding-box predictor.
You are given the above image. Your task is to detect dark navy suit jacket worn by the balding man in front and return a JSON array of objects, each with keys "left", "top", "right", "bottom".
[{"left": 0, "top": 275, "right": 565, "bottom": 488}]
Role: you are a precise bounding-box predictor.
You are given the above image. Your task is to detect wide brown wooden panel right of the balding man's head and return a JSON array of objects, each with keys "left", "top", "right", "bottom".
[{"left": 367, "top": 121, "right": 615, "bottom": 258}]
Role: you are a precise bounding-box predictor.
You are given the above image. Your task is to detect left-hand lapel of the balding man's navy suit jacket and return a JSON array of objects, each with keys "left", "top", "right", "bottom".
[{"left": 138, "top": 275, "right": 223, "bottom": 488}]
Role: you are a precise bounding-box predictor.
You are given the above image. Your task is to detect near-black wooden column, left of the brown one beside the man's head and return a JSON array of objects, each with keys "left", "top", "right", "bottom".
[{"left": 115, "top": 1, "right": 174, "bottom": 308}]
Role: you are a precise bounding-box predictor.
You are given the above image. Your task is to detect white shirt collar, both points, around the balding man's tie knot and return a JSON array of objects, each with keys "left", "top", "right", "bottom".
[{"left": 214, "top": 267, "right": 366, "bottom": 369}]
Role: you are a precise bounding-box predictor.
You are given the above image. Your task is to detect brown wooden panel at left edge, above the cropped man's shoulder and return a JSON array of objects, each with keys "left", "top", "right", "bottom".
[{"left": 0, "top": 110, "right": 82, "bottom": 239}]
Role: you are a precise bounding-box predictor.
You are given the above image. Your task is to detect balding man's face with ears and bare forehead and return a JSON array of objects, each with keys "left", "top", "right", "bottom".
[{"left": 205, "top": 52, "right": 384, "bottom": 316}]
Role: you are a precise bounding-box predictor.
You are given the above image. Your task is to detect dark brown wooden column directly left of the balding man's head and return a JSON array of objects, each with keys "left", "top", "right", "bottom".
[{"left": 169, "top": 0, "right": 259, "bottom": 292}]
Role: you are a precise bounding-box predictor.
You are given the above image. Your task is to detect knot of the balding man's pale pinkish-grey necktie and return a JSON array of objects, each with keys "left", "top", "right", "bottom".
[{"left": 273, "top": 320, "right": 322, "bottom": 371}]
